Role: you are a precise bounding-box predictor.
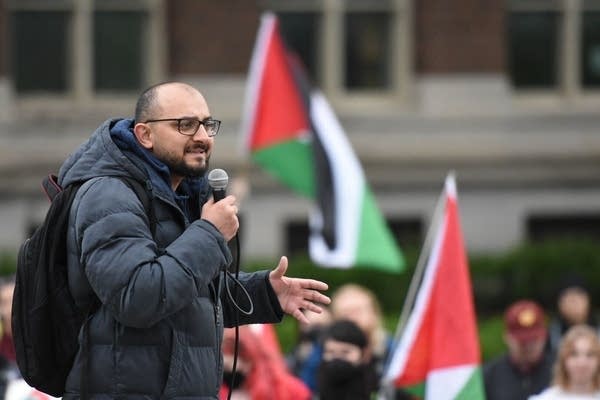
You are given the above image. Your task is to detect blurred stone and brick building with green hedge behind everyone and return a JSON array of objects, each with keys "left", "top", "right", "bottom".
[{"left": 0, "top": 0, "right": 600, "bottom": 357}]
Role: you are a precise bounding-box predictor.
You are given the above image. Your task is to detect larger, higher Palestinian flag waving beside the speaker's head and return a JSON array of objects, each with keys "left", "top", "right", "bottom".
[{"left": 242, "top": 13, "right": 404, "bottom": 272}]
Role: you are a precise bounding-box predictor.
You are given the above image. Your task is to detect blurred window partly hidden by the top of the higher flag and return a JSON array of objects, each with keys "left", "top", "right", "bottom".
[{"left": 262, "top": 0, "right": 412, "bottom": 105}]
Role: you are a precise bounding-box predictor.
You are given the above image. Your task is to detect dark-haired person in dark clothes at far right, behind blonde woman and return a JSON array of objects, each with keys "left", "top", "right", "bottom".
[{"left": 548, "top": 273, "right": 600, "bottom": 352}]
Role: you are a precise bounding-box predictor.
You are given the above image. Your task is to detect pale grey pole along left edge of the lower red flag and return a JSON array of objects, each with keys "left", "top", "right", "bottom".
[{"left": 394, "top": 174, "right": 450, "bottom": 343}]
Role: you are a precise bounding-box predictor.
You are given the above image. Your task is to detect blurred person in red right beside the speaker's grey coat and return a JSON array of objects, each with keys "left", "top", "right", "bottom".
[{"left": 220, "top": 325, "right": 312, "bottom": 400}]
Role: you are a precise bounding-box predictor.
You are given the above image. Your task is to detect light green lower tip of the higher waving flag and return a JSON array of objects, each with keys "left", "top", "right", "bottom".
[{"left": 356, "top": 188, "right": 404, "bottom": 272}]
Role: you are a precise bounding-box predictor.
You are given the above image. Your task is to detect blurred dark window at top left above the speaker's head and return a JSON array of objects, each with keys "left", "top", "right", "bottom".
[{"left": 8, "top": 0, "right": 161, "bottom": 99}]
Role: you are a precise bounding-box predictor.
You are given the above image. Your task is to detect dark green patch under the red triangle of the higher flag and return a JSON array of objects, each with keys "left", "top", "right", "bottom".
[{"left": 252, "top": 139, "right": 316, "bottom": 199}]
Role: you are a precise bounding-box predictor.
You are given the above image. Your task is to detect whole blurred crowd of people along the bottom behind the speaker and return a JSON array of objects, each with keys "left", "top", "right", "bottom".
[{"left": 0, "top": 278, "right": 600, "bottom": 400}]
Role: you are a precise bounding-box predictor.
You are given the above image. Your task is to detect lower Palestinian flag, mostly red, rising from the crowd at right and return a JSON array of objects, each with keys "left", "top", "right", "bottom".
[{"left": 384, "top": 175, "right": 485, "bottom": 400}]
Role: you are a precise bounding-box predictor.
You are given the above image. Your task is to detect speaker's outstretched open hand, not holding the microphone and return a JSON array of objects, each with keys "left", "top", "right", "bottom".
[{"left": 269, "top": 256, "right": 331, "bottom": 324}]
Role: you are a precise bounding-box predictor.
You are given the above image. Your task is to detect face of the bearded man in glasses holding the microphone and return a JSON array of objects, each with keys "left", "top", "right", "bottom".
[{"left": 142, "top": 84, "right": 214, "bottom": 178}]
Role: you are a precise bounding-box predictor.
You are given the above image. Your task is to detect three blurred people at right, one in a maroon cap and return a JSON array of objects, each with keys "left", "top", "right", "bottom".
[{"left": 483, "top": 277, "right": 600, "bottom": 400}]
